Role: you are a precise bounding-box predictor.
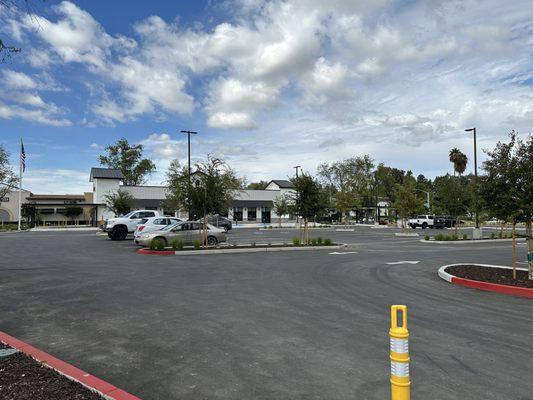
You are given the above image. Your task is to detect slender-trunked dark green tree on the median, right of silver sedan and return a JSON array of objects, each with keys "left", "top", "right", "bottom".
[{"left": 291, "top": 172, "right": 327, "bottom": 244}]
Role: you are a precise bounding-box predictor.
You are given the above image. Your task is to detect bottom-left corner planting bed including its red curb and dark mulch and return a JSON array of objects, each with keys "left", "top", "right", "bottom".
[{"left": 0, "top": 331, "right": 140, "bottom": 400}]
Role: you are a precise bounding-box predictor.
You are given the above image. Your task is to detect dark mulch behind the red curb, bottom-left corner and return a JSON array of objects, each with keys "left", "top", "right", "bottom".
[{"left": 0, "top": 342, "right": 105, "bottom": 400}]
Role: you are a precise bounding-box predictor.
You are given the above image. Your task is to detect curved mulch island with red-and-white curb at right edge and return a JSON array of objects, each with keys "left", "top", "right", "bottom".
[{"left": 439, "top": 264, "right": 533, "bottom": 298}]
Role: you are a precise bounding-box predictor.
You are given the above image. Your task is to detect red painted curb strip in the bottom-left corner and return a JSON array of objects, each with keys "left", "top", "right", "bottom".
[{"left": 0, "top": 331, "right": 141, "bottom": 400}]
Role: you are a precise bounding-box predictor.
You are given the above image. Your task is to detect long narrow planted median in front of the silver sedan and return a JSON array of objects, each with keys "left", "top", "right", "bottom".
[{"left": 137, "top": 239, "right": 346, "bottom": 256}]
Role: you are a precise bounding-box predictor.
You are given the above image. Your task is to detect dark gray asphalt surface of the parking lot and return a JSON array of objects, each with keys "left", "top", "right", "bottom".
[{"left": 0, "top": 227, "right": 533, "bottom": 400}]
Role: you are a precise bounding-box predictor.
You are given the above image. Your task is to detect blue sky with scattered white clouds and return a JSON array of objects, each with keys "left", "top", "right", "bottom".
[{"left": 0, "top": 0, "right": 533, "bottom": 193}]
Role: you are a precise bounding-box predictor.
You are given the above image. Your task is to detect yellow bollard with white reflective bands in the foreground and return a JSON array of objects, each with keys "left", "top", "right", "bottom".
[{"left": 389, "top": 306, "right": 411, "bottom": 400}]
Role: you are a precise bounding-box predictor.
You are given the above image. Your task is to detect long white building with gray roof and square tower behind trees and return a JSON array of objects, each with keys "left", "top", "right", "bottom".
[{"left": 89, "top": 168, "right": 294, "bottom": 224}]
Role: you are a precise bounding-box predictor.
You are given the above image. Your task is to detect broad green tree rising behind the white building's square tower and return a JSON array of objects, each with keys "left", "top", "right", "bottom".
[{"left": 98, "top": 138, "right": 155, "bottom": 186}]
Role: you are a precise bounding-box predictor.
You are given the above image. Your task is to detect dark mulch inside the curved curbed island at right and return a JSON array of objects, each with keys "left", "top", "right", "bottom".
[{"left": 446, "top": 265, "right": 533, "bottom": 289}]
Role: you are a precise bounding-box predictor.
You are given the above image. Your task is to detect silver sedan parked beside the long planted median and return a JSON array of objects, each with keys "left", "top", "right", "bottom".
[{"left": 134, "top": 221, "right": 226, "bottom": 246}]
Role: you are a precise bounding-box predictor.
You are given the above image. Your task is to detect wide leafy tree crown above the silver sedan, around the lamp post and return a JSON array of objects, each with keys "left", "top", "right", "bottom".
[{"left": 164, "top": 155, "right": 243, "bottom": 218}]
